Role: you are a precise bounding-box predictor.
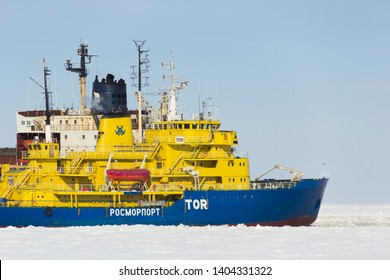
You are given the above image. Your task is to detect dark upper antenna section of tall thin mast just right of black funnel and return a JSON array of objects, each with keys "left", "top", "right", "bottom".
[{"left": 131, "top": 40, "right": 150, "bottom": 91}]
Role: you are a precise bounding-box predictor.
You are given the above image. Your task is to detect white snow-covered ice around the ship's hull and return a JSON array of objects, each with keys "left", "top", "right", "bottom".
[{"left": 0, "top": 204, "right": 390, "bottom": 260}]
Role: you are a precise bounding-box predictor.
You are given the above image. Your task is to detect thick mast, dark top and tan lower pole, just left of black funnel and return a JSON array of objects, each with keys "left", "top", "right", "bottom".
[{"left": 65, "top": 43, "right": 96, "bottom": 110}]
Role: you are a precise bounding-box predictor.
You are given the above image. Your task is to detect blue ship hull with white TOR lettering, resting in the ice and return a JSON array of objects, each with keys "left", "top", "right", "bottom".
[{"left": 0, "top": 178, "right": 328, "bottom": 227}]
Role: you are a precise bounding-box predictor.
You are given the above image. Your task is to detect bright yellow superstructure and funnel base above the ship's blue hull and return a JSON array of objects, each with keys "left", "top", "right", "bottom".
[{"left": 0, "top": 115, "right": 250, "bottom": 208}]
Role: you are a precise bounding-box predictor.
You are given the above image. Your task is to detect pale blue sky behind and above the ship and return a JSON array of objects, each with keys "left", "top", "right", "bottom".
[{"left": 0, "top": 0, "right": 390, "bottom": 203}]
